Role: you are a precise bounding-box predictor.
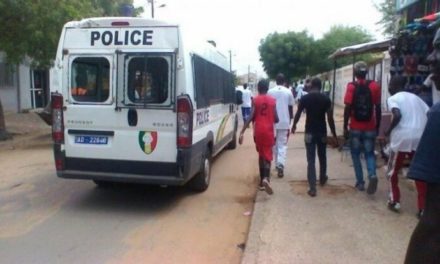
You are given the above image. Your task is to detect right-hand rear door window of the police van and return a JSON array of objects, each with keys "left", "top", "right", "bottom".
[{"left": 127, "top": 57, "right": 169, "bottom": 104}]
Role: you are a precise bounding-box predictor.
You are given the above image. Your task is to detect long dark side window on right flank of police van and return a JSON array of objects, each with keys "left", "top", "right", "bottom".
[{"left": 193, "top": 55, "right": 235, "bottom": 108}]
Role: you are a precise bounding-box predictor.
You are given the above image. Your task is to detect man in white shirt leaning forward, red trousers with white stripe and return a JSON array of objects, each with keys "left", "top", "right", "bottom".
[{"left": 385, "top": 76, "right": 429, "bottom": 216}]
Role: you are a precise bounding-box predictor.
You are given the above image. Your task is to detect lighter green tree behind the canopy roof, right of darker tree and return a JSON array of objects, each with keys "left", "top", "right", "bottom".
[{"left": 310, "top": 25, "right": 373, "bottom": 74}]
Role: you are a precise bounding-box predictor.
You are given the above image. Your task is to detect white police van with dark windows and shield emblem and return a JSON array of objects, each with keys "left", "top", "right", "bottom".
[{"left": 51, "top": 17, "right": 238, "bottom": 191}]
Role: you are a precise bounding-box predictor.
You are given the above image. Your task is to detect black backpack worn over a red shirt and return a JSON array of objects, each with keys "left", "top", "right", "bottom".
[{"left": 352, "top": 81, "right": 373, "bottom": 122}]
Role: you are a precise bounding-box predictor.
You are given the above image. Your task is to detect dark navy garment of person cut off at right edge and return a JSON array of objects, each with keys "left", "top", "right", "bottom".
[{"left": 408, "top": 103, "right": 440, "bottom": 183}]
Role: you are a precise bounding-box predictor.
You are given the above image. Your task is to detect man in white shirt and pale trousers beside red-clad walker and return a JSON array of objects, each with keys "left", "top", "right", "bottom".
[{"left": 268, "top": 73, "right": 295, "bottom": 178}]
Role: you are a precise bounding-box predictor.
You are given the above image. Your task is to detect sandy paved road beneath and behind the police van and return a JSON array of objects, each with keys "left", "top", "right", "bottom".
[{"left": 0, "top": 137, "right": 257, "bottom": 263}]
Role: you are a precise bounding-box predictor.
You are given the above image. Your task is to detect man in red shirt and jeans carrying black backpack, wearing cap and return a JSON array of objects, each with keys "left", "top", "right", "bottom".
[{"left": 343, "top": 61, "right": 382, "bottom": 194}]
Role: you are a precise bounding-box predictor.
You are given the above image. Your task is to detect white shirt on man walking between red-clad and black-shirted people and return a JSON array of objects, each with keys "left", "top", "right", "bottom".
[{"left": 268, "top": 85, "right": 295, "bottom": 129}]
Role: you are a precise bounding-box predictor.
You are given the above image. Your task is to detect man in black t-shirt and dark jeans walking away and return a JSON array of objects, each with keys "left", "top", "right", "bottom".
[{"left": 292, "top": 78, "right": 337, "bottom": 197}]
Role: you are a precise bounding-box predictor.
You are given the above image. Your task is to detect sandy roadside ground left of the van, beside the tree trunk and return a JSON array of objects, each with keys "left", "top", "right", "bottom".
[{"left": 0, "top": 112, "right": 52, "bottom": 151}]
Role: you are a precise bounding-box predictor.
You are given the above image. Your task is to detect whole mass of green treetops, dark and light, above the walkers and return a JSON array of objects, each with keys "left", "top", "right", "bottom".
[{"left": 259, "top": 25, "right": 372, "bottom": 80}]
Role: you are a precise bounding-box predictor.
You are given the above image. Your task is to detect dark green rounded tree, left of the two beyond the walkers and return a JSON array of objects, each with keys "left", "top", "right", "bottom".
[{"left": 258, "top": 31, "right": 314, "bottom": 80}]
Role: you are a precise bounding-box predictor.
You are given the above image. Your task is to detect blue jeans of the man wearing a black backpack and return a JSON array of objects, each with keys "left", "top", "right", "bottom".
[{"left": 350, "top": 130, "right": 376, "bottom": 185}]
